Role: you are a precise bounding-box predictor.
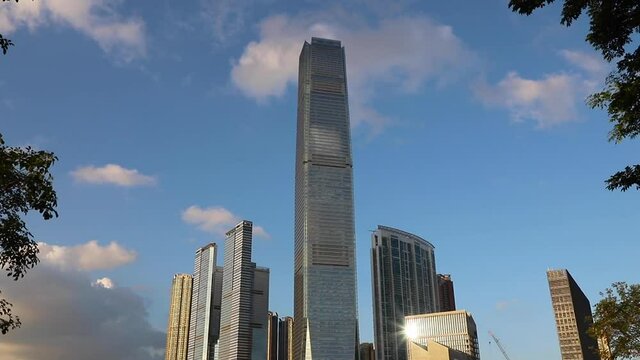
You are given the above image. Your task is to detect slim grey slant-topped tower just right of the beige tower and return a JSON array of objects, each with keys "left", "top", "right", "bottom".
[{"left": 187, "top": 243, "right": 222, "bottom": 360}]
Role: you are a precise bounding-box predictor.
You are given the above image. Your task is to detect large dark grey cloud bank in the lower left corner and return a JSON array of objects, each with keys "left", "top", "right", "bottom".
[{"left": 0, "top": 264, "right": 166, "bottom": 360}]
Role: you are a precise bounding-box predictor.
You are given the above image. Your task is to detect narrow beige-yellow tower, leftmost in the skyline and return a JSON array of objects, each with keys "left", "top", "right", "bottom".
[{"left": 164, "top": 274, "right": 193, "bottom": 360}]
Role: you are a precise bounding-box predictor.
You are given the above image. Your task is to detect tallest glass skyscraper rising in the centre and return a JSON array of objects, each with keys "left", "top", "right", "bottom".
[{"left": 293, "top": 38, "right": 359, "bottom": 360}]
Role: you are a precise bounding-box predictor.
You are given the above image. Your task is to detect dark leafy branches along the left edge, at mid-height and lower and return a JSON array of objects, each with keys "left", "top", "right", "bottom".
[{"left": 0, "top": 134, "right": 58, "bottom": 334}]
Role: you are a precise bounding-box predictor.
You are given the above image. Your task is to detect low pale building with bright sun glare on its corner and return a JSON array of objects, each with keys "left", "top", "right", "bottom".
[{"left": 405, "top": 310, "right": 480, "bottom": 360}]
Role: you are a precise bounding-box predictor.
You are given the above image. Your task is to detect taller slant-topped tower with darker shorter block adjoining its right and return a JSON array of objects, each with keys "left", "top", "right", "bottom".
[{"left": 218, "top": 220, "right": 269, "bottom": 360}]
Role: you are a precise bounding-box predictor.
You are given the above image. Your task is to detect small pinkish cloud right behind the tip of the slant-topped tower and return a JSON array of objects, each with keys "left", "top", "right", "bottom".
[{"left": 182, "top": 205, "right": 271, "bottom": 239}]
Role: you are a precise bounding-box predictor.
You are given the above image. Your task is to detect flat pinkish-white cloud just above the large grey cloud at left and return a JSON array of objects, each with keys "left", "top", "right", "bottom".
[{"left": 38, "top": 240, "right": 137, "bottom": 271}]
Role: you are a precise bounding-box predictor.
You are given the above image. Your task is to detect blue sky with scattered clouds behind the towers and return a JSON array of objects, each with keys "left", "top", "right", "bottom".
[{"left": 0, "top": 0, "right": 640, "bottom": 360}]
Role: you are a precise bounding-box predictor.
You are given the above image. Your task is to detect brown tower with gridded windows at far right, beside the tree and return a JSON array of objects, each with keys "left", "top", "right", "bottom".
[{"left": 547, "top": 269, "right": 600, "bottom": 360}]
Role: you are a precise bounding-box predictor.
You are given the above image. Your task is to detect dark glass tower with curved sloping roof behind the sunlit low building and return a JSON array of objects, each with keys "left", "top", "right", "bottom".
[{"left": 371, "top": 225, "right": 439, "bottom": 360}]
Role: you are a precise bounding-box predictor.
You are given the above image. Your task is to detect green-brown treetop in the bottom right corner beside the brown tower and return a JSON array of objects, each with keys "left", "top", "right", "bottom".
[{"left": 589, "top": 282, "right": 640, "bottom": 360}]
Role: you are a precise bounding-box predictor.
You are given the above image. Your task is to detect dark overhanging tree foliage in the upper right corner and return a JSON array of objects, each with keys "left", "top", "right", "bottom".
[{"left": 509, "top": 0, "right": 640, "bottom": 191}]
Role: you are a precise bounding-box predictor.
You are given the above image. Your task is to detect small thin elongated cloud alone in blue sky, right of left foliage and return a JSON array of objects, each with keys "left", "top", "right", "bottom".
[{"left": 71, "top": 164, "right": 157, "bottom": 187}]
